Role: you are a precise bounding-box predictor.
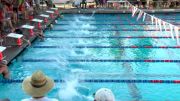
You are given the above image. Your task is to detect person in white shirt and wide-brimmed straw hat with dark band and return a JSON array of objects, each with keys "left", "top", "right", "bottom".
[{"left": 21, "top": 71, "right": 58, "bottom": 101}]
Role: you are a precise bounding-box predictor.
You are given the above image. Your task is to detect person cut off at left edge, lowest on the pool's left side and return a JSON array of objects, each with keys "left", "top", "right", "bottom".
[{"left": 0, "top": 60, "right": 9, "bottom": 79}]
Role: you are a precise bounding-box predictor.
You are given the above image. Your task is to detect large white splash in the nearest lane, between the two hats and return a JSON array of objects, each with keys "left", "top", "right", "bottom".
[{"left": 59, "top": 75, "right": 91, "bottom": 101}]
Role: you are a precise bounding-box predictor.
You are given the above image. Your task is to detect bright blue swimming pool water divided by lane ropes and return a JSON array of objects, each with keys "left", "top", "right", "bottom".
[{"left": 0, "top": 13, "right": 180, "bottom": 101}]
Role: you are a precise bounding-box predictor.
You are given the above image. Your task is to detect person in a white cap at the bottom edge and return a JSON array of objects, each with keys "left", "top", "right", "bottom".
[{"left": 94, "top": 88, "right": 115, "bottom": 101}]
